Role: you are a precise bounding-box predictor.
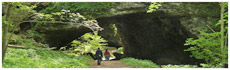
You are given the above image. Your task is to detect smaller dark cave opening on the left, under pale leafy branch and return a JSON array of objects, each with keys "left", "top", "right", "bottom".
[{"left": 20, "top": 23, "right": 92, "bottom": 49}]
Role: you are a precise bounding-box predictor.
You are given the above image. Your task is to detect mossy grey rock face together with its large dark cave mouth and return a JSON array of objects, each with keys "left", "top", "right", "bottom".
[{"left": 97, "top": 3, "right": 219, "bottom": 64}]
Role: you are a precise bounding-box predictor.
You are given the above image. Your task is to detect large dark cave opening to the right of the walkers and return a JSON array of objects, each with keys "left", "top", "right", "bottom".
[{"left": 97, "top": 12, "right": 200, "bottom": 64}]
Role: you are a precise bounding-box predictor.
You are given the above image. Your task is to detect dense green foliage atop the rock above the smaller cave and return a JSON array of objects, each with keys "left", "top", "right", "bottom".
[{"left": 40, "top": 2, "right": 117, "bottom": 16}]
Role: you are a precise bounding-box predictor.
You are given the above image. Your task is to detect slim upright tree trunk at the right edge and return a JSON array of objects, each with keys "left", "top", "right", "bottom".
[{"left": 220, "top": 2, "right": 225, "bottom": 63}]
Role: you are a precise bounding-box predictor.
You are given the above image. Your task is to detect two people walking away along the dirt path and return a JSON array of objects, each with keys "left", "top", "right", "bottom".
[{"left": 95, "top": 48, "right": 110, "bottom": 65}]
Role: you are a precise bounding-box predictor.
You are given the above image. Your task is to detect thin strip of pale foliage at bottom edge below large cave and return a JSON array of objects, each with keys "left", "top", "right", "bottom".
[{"left": 161, "top": 64, "right": 198, "bottom": 68}]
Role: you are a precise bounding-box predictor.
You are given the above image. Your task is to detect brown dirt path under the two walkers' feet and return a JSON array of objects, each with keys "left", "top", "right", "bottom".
[{"left": 89, "top": 60, "right": 131, "bottom": 68}]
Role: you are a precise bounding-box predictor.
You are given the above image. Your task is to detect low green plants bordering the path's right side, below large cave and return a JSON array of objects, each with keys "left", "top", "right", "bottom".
[{"left": 121, "top": 57, "right": 160, "bottom": 68}]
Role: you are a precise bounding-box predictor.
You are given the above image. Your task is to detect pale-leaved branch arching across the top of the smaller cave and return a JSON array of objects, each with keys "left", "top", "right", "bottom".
[{"left": 33, "top": 9, "right": 103, "bottom": 31}]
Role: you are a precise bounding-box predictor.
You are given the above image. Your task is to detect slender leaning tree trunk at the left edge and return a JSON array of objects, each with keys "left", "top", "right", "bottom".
[{"left": 2, "top": 3, "right": 13, "bottom": 61}]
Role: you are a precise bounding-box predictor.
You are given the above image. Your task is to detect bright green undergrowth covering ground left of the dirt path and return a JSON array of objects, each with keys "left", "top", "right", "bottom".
[{"left": 2, "top": 48, "right": 92, "bottom": 68}]
